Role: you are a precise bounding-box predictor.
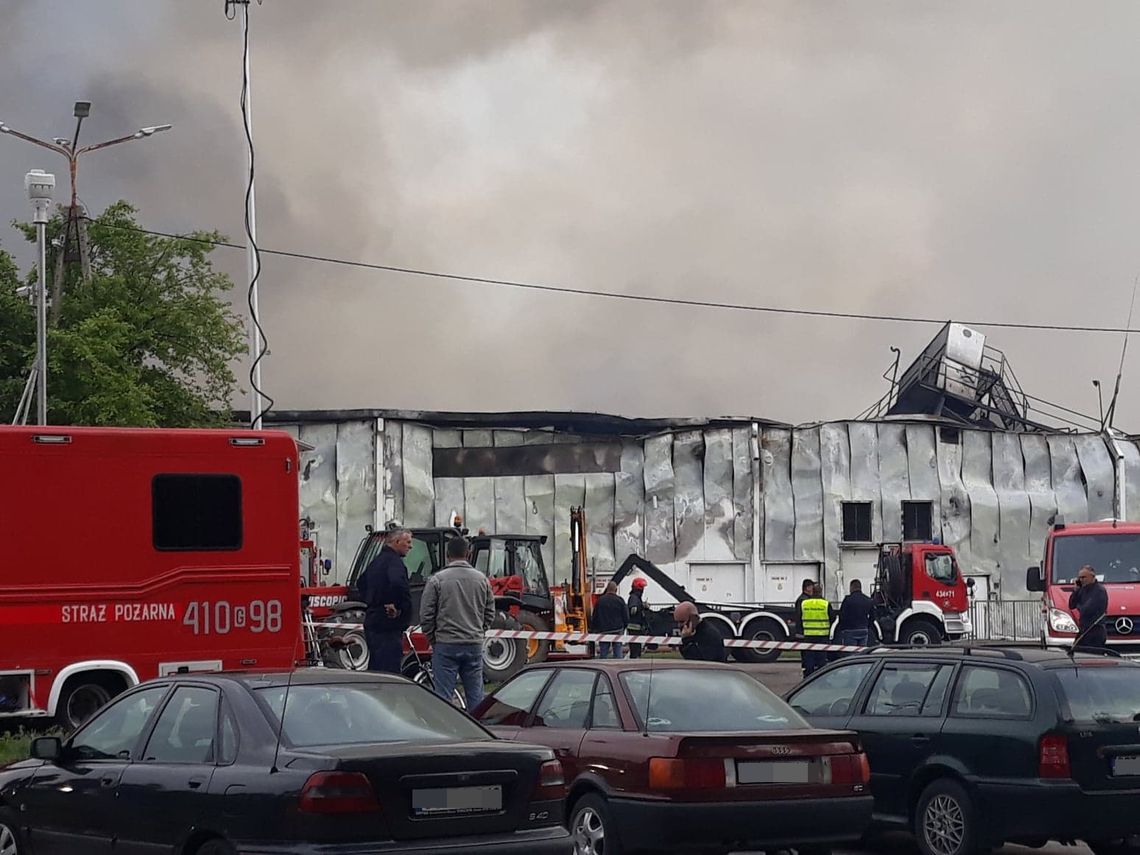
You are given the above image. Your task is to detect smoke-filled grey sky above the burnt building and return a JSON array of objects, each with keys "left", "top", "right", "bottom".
[{"left": 0, "top": 0, "right": 1140, "bottom": 430}]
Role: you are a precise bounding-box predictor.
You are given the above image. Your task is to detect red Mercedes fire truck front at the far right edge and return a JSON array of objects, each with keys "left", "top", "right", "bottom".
[{"left": 1025, "top": 519, "right": 1140, "bottom": 653}]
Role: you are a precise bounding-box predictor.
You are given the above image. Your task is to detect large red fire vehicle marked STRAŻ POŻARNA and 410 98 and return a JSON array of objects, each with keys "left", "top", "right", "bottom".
[{"left": 0, "top": 428, "right": 304, "bottom": 726}]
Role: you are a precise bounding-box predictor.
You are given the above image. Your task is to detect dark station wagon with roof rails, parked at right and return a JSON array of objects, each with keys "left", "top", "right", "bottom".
[{"left": 788, "top": 645, "right": 1140, "bottom": 855}]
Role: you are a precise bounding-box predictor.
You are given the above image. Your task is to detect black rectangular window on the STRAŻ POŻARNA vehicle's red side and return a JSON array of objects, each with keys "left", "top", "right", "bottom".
[{"left": 150, "top": 474, "right": 242, "bottom": 552}]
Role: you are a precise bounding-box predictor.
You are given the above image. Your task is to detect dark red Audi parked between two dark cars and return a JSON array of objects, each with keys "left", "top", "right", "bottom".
[{"left": 474, "top": 659, "right": 871, "bottom": 855}]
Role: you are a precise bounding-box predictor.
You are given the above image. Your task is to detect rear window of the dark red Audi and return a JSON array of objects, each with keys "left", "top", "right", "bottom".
[{"left": 621, "top": 668, "right": 811, "bottom": 733}]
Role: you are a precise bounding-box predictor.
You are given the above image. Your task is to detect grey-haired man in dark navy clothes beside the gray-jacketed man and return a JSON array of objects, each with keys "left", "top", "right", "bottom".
[{"left": 357, "top": 529, "right": 412, "bottom": 674}]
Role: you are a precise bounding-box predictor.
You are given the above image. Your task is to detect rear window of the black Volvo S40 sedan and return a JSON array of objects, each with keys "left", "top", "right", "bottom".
[{"left": 257, "top": 683, "right": 494, "bottom": 748}]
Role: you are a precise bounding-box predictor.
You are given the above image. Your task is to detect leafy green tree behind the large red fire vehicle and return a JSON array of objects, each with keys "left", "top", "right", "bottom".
[{"left": 0, "top": 202, "right": 243, "bottom": 428}]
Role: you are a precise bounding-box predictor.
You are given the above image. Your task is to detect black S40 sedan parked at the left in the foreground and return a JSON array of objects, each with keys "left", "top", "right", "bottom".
[{"left": 0, "top": 670, "right": 571, "bottom": 855}]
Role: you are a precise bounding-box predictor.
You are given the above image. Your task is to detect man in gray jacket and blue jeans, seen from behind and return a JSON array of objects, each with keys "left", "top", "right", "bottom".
[{"left": 420, "top": 537, "right": 495, "bottom": 709}]
